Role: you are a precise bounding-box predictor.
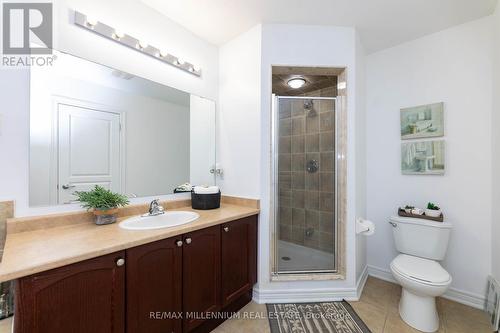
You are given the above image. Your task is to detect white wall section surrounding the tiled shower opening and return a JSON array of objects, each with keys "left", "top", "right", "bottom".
[{"left": 254, "top": 24, "right": 357, "bottom": 300}]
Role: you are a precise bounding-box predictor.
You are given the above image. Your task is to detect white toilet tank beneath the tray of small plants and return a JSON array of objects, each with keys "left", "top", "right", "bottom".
[{"left": 389, "top": 216, "right": 451, "bottom": 260}]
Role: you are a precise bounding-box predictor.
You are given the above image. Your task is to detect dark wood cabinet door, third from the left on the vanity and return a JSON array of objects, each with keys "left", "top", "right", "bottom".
[{"left": 182, "top": 226, "right": 221, "bottom": 332}]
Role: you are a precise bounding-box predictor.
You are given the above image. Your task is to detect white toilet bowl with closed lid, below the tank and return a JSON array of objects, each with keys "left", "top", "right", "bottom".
[{"left": 391, "top": 254, "right": 451, "bottom": 332}]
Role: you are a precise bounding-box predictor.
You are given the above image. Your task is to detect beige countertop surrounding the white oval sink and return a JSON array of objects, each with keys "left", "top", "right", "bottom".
[{"left": 0, "top": 200, "right": 259, "bottom": 282}]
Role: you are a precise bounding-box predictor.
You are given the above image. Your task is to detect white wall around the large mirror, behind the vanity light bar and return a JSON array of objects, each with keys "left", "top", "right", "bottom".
[{"left": 0, "top": 0, "right": 218, "bottom": 216}]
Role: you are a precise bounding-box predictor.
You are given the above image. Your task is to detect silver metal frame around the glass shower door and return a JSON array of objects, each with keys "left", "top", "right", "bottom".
[{"left": 270, "top": 94, "right": 345, "bottom": 281}]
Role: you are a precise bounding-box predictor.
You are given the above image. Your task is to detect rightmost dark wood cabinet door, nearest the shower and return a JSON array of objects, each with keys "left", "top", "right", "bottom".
[{"left": 221, "top": 216, "right": 257, "bottom": 306}]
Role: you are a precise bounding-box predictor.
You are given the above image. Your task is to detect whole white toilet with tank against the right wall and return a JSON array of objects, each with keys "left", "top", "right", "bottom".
[{"left": 389, "top": 216, "right": 452, "bottom": 332}]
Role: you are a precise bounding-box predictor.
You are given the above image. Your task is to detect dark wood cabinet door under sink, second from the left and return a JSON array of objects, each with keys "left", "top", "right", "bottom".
[{"left": 127, "top": 236, "right": 182, "bottom": 333}]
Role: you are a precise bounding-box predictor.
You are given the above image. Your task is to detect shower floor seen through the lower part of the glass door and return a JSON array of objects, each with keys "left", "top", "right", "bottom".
[{"left": 278, "top": 241, "right": 333, "bottom": 272}]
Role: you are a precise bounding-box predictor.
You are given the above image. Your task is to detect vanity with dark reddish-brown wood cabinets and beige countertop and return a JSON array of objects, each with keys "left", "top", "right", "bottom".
[{"left": 0, "top": 198, "right": 258, "bottom": 333}]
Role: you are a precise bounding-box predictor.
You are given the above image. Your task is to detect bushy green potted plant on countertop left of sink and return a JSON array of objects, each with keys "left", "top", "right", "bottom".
[{"left": 75, "top": 185, "right": 129, "bottom": 225}]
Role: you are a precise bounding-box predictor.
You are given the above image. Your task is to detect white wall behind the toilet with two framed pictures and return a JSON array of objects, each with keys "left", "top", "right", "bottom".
[{"left": 367, "top": 18, "right": 496, "bottom": 306}]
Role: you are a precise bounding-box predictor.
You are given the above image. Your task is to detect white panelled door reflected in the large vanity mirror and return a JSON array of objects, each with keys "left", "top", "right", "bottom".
[{"left": 57, "top": 104, "right": 121, "bottom": 204}]
